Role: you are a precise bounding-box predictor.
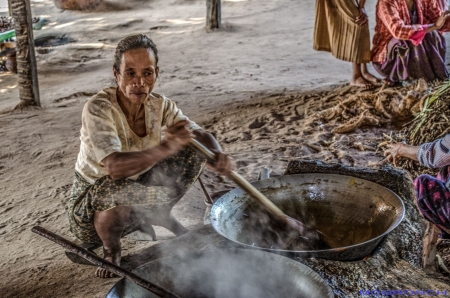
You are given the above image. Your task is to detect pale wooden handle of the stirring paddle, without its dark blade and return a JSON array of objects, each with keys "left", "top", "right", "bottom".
[{"left": 190, "top": 139, "right": 287, "bottom": 220}]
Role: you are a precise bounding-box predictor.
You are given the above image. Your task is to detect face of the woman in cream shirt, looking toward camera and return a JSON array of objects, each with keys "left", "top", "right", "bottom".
[{"left": 114, "top": 48, "right": 159, "bottom": 104}]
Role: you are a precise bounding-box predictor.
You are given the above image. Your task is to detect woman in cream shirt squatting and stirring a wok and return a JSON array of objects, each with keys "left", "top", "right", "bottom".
[{"left": 68, "top": 35, "right": 231, "bottom": 277}]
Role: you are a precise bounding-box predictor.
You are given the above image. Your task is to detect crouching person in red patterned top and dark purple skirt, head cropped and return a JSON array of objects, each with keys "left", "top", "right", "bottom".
[{"left": 371, "top": 0, "right": 450, "bottom": 85}]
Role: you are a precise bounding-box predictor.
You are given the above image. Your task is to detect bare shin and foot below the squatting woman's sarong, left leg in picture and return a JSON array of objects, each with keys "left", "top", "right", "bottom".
[{"left": 94, "top": 206, "right": 131, "bottom": 278}]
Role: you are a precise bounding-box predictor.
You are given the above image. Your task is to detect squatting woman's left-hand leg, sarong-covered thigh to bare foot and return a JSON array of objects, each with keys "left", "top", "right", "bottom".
[{"left": 73, "top": 176, "right": 175, "bottom": 278}]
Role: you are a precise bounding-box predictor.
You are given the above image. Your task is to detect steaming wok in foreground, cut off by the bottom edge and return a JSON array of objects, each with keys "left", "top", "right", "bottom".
[{"left": 106, "top": 249, "right": 333, "bottom": 298}]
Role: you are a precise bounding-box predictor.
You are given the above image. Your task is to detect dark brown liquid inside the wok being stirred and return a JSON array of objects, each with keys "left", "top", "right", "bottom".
[{"left": 237, "top": 200, "right": 383, "bottom": 251}]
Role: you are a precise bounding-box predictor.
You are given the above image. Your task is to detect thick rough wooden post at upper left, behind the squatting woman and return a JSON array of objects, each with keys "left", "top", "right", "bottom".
[{"left": 10, "top": 0, "right": 41, "bottom": 108}]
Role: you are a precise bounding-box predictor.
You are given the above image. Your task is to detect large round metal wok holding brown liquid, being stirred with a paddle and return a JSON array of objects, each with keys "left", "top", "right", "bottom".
[{"left": 211, "top": 173, "right": 405, "bottom": 260}]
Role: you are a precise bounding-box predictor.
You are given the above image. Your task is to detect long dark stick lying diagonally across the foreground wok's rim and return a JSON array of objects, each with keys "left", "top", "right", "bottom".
[{"left": 31, "top": 226, "right": 180, "bottom": 298}]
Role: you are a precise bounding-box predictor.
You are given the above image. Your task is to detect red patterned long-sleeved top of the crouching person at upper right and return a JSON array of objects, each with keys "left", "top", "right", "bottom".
[{"left": 371, "top": 0, "right": 450, "bottom": 63}]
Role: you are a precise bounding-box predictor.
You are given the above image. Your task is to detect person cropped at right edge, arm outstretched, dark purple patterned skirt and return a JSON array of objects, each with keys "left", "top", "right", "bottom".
[{"left": 384, "top": 134, "right": 450, "bottom": 239}]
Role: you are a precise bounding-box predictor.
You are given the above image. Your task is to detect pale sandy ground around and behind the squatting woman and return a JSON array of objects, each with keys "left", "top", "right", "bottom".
[{"left": 0, "top": 0, "right": 450, "bottom": 297}]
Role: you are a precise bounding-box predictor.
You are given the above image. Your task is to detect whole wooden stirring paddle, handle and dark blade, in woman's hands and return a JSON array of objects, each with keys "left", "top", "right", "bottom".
[{"left": 189, "top": 139, "right": 319, "bottom": 249}]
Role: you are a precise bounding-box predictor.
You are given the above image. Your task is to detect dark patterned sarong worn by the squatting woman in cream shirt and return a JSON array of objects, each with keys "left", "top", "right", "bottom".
[{"left": 68, "top": 147, "right": 206, "bottom": 243}]
